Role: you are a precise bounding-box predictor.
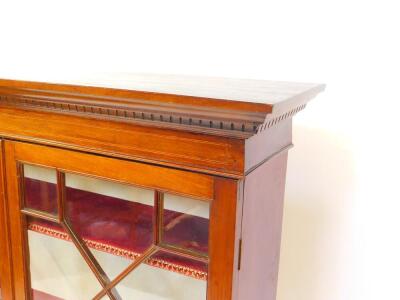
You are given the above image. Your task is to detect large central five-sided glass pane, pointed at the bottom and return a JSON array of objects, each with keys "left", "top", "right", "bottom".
[{"left": 66, "top": 174, "right": 154, "bottom": 279}]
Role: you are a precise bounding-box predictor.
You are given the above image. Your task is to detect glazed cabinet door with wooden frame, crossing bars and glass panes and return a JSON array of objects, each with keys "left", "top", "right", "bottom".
[{"left": 4, "top": 141, "right": 236, "bottom": 300}]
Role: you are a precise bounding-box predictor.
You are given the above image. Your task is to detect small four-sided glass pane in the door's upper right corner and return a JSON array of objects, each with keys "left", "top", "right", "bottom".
[{"left": 163, "top": 194, "right": 210, "bottom": 254}]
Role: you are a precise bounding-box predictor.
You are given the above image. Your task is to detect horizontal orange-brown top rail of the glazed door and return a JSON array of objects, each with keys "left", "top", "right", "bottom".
[{"left": 10, "top": 142, "right": 214, "bottom": 201}]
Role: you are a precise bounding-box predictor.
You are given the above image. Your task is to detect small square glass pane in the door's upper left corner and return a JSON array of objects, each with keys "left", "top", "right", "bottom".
[{"left": 24, "top": 165, "right": 57, "bottom": 215}]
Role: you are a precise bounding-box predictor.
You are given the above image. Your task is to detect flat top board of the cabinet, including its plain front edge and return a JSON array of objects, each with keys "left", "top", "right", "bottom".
[{"left": 0, "top": 74, "right": 324, "bottom": 112}]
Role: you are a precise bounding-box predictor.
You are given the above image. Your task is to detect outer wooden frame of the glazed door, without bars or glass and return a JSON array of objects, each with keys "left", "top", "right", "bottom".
[{"left": 4, "top": 141, "right": 237, "bottom": 300}]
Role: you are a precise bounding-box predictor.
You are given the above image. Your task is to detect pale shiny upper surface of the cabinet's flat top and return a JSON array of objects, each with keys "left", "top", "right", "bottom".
[{"left": 0, "top": 73, "right": 324, "bottom": 112}]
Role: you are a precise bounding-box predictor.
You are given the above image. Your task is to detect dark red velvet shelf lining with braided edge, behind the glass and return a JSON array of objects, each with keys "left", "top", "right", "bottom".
[{"left": 25, "top": 178, "right": 209, "bottom": 279}]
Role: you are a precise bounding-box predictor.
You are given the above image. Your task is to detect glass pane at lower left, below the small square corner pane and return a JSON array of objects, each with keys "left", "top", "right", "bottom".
[{"left": 28, "top": 218, "right": 101, "bottom": 300}]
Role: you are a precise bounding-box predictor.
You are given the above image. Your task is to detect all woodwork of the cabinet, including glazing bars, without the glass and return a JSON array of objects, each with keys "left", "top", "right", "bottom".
[{"left": 0, "top": 75, "right": 324, "bottom": 300}]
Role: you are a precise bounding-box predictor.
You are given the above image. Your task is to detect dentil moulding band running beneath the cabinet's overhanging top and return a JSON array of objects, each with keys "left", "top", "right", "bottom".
[{"left": 0, "top": 94, "right": 306, "bottom": 138}]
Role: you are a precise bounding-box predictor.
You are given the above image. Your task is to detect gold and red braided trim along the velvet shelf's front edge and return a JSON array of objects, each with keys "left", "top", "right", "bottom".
[{"left": 28, "top": 224, "right": 208, "bottom": 280}]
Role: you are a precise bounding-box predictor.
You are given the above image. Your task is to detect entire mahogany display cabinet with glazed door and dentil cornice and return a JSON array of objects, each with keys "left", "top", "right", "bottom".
[{"left": 0, "top": 75, "right": 324, "bottom": 300}]
